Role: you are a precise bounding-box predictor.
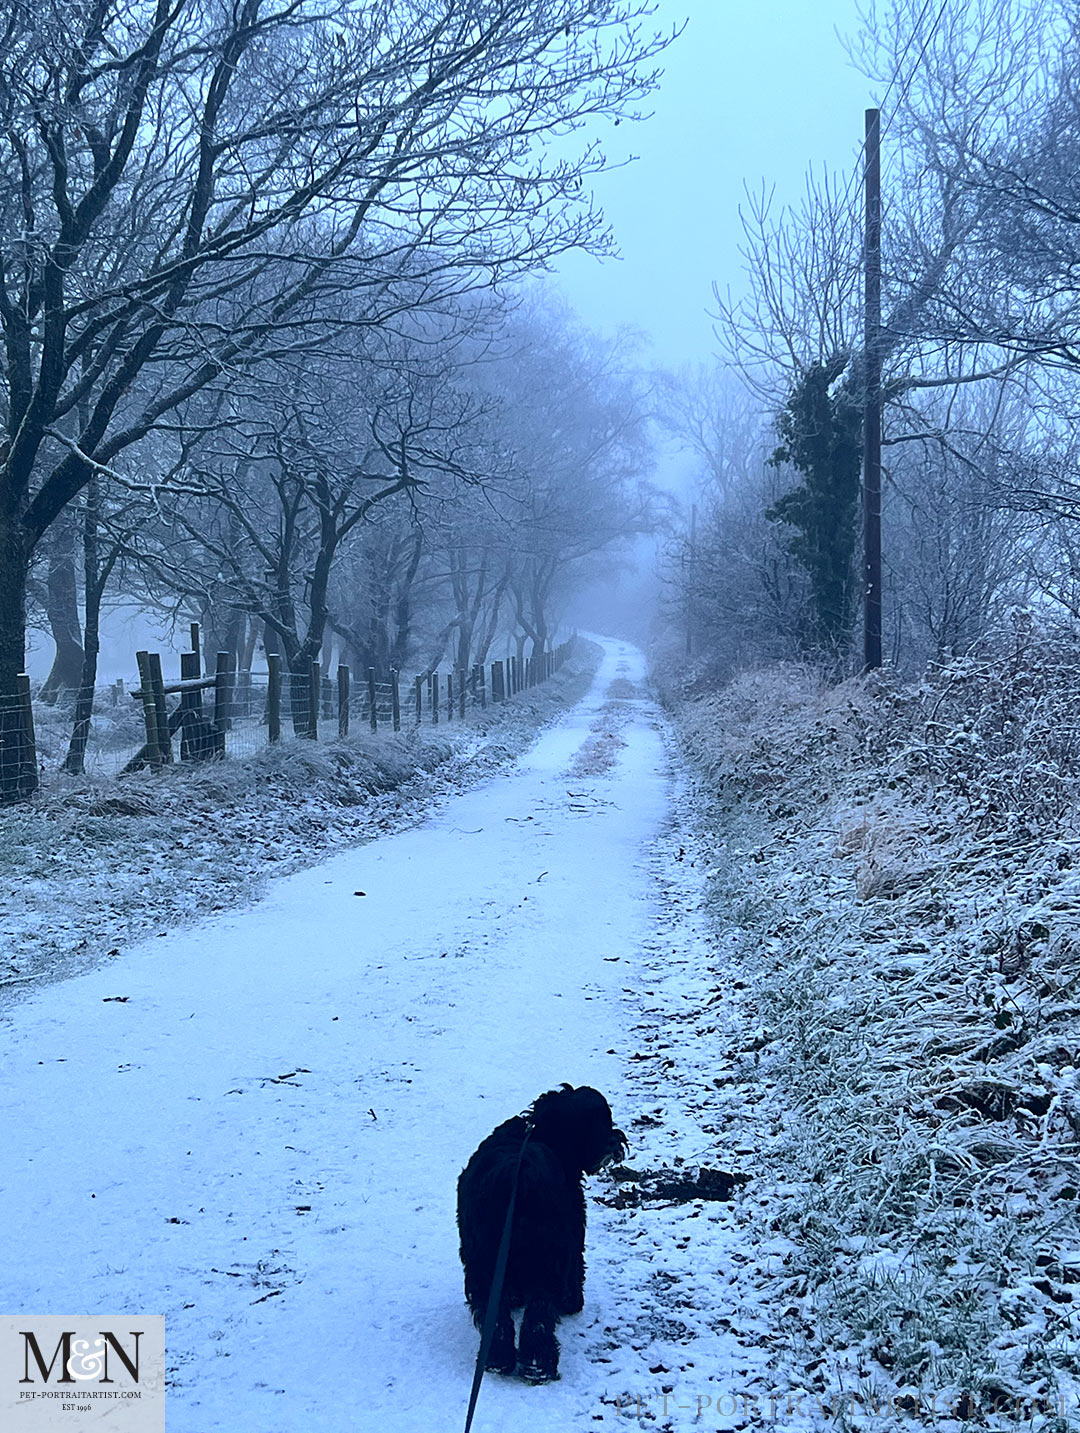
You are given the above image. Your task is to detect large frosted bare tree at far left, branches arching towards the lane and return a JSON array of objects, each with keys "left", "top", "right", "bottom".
[{"left": 0, "top": 0, "right": 665, "bottom": 785}]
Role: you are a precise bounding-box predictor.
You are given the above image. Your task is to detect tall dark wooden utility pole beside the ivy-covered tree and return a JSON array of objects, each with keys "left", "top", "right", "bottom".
[{"left": 862, "top": 109, "right": 881, "bottom": 672}]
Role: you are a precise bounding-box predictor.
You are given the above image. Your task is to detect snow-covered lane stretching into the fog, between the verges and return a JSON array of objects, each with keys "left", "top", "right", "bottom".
[{"left": 0, "top": 642, "right": 756, "bottom": 1433}]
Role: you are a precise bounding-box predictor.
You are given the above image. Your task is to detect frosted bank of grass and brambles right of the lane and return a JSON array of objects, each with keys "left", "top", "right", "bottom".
[{"left": 679, "top": 628, "right": 1080, "bottom": 1427}]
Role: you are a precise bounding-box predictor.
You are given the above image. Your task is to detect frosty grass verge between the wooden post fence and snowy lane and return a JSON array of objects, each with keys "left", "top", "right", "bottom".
[{"left": 0, "top": 642, "right": 600, "bottom": 996}]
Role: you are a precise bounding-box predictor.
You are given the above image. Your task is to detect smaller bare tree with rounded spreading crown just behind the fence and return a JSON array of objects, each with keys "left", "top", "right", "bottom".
[{"left": 137, "top": 334, "right": 476, "bottom": 734}]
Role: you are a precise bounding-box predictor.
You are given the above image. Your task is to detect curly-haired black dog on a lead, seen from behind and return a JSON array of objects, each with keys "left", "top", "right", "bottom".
[{"left": 457, "top": 1085, "right": 626, "bottom": 1383}]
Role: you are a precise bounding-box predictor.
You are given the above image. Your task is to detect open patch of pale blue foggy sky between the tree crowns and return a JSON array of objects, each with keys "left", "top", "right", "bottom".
[{"left": 557, "top": 0, "right": 874, "bottom": 367}]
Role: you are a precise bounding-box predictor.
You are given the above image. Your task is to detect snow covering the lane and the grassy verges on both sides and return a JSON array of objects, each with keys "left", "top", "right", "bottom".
[{"left": 23, "top": 641, "right": 1080, "bottom": 1433}]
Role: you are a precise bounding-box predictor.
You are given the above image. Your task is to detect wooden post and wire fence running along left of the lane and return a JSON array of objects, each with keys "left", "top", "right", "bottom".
[{"left": 0, "top": 623, "right": 573, "bottom": 802}]
